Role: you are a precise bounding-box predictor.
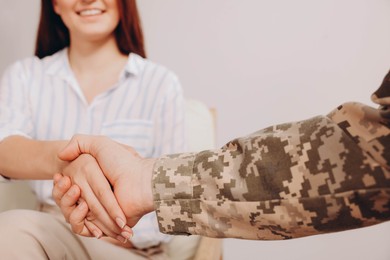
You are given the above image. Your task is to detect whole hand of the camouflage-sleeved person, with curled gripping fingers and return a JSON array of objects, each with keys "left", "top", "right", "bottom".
[{"left": 53, "top": 135, "right": 155, "bottom": 237}]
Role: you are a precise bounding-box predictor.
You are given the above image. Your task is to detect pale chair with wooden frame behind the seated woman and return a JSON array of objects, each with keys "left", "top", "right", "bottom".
[{"left": 0, "top": 99, "right": 222, "bottom": 260}]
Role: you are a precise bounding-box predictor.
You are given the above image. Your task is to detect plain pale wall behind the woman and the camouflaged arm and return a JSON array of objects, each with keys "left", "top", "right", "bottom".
[{"left": 0, "top": 0, "right": 390, "bottom": 260}]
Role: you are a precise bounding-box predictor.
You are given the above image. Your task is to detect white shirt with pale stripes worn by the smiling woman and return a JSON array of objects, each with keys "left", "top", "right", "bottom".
[{"left": 0, "top": 49, "right": 186, "bottom": 247}]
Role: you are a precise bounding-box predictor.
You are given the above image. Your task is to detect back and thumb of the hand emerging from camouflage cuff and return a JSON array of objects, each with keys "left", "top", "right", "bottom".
[{"left": 57, "top": 135, "right": 155, "bottom": 227}]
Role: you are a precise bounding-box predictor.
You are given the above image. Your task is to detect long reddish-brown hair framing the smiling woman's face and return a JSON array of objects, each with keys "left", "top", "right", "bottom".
[{"left": 35, "top": 0, "right": 146, "bottom": 58}]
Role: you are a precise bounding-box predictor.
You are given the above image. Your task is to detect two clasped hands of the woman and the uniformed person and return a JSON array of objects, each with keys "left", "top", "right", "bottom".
[{"left": 53, "top": 135, "right": 155, "bottom": 243}]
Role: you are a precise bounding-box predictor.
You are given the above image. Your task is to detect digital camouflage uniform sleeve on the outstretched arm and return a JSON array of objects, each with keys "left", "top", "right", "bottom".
[{"left": 153, "top": 72, "right": 390, "bottom": 240}]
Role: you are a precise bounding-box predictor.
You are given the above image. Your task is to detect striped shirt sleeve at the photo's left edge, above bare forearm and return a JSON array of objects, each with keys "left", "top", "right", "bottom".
[{"left": 0, "top": 62, "right": 33, "bottom": 182}]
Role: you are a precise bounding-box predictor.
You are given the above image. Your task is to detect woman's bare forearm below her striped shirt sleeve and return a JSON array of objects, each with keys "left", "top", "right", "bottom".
[{"left": 0, "top": 136, "right": 67, "bottom": 180}]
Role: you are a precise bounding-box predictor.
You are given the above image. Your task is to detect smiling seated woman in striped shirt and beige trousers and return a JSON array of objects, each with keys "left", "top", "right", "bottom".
[{"left": 0, "top": 0, "right": 190, "bottom": 259}]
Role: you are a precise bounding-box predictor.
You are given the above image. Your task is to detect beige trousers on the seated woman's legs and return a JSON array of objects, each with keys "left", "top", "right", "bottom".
[{"left": 0, "top": 206, "right": 199, "bottom": 260}]
